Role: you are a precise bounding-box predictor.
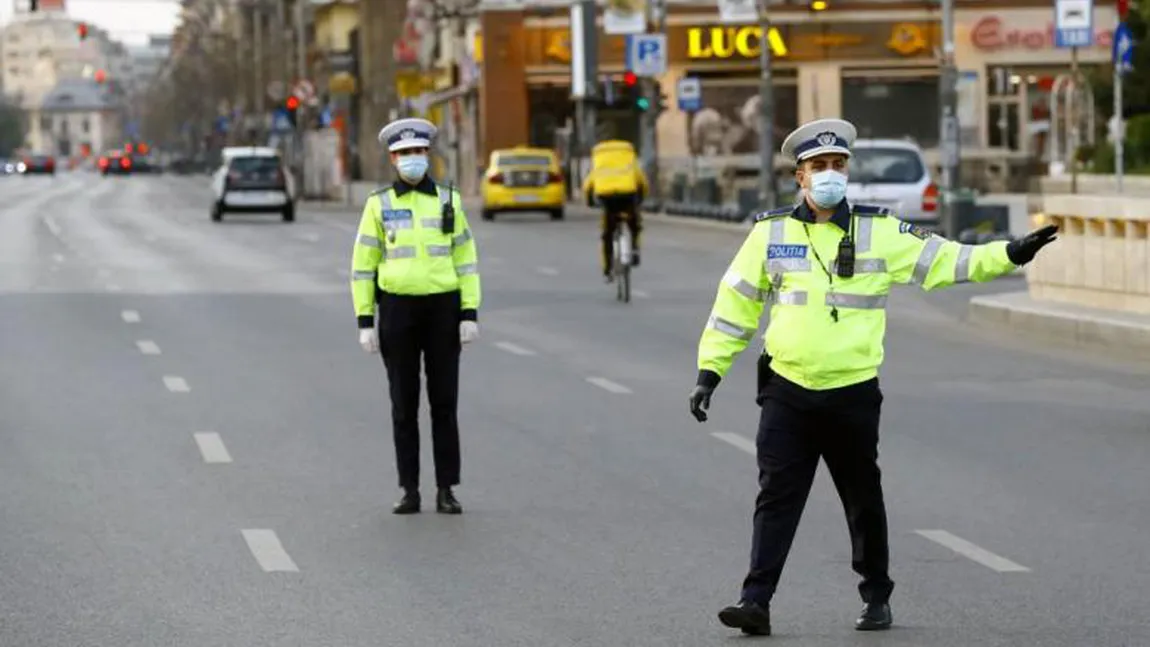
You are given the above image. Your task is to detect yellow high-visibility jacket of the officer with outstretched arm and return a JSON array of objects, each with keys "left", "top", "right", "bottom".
[{"left": 698, "top": 202, "right": 1015, "bottom": 391}]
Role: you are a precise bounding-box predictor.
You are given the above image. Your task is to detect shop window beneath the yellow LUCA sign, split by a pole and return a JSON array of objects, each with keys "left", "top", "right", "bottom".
[{"left": 688, "top": 71, "right": 798, "bottom": 155}]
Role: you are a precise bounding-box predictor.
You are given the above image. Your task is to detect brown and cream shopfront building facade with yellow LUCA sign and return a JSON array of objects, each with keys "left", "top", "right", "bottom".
[{"left": 480, "top": 0, "right": 1117, "bottom": 172}]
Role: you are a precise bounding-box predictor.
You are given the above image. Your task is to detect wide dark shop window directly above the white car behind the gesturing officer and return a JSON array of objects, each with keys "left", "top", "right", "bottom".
[{"left": 842, "top": 70, "right": 938, "bottom": 148}]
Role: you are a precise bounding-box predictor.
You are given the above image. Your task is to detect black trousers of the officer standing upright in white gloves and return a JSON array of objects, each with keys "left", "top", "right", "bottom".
[{"left": 378, "top": 292, "right": 461, "bottom": 488}]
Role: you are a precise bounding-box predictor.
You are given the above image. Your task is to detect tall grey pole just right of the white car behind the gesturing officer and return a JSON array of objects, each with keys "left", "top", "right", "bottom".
[{"left": 938, "top": 0, "right": 959, "bottom": 238}]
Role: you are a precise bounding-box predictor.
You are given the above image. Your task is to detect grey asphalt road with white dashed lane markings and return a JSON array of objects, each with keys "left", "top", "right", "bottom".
[{"left": 0, "top": 174, "right": 1150, "bottom": 647}]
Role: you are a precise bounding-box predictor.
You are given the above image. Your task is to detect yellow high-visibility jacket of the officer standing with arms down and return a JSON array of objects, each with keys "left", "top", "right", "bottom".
[{"left": 351, "top": 177, "right": 482, "bottom": 328}]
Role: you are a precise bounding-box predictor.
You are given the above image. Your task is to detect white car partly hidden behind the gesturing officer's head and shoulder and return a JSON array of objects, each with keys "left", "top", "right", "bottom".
[{"left": 846, "top": 139, "right": 938, "bottom": 225}]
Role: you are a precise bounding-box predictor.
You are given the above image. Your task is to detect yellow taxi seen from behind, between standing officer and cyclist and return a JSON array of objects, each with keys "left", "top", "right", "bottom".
[{"left": 483, "top": 146, "right": 567, "bottom": 221}]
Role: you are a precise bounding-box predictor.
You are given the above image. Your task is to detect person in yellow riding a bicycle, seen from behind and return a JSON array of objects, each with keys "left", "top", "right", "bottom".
[{"left": 583, "top": 139, "right": 649, "bottom": 283}]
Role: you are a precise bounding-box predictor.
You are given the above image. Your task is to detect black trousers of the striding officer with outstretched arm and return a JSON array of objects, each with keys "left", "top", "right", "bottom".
[{"left": 743, "top": 375, "right": 895, "bottom": 606}]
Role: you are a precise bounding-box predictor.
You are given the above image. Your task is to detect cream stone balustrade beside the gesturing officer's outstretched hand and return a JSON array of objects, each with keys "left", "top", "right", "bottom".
[{"left": 1027, "top": 194, "right": 1150, "bottom": 314}]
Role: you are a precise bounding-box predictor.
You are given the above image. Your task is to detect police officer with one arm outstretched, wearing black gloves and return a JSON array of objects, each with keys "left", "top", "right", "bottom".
[{"left": 690, "top": 120, "right": 1057, "bottom": 634}]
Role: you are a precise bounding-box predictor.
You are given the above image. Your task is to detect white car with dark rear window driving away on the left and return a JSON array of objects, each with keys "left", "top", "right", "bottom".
[{"left": 212, "top": 146, "right": 296, "bottom": 223}]
